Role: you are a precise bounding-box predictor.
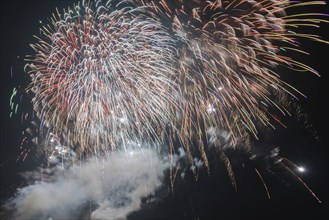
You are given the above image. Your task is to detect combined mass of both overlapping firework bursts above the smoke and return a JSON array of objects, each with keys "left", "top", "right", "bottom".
[{"left": 19, "top": 0, "right": 328, "bottom": 187}]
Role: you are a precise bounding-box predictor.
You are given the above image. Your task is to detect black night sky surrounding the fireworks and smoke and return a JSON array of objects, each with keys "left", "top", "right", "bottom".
[{"left": 0, "top": 0, "right": 329, "bottom": 219}]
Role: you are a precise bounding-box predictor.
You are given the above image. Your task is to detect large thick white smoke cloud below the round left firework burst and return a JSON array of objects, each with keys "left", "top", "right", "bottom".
[{"left": 6, "top": 149, "right": 174, "bottom": 220}]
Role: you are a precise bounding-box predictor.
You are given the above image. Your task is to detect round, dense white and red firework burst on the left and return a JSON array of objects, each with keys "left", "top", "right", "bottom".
[{"left": 28, "top": 2, "right": 177, "bottom": 158}]
